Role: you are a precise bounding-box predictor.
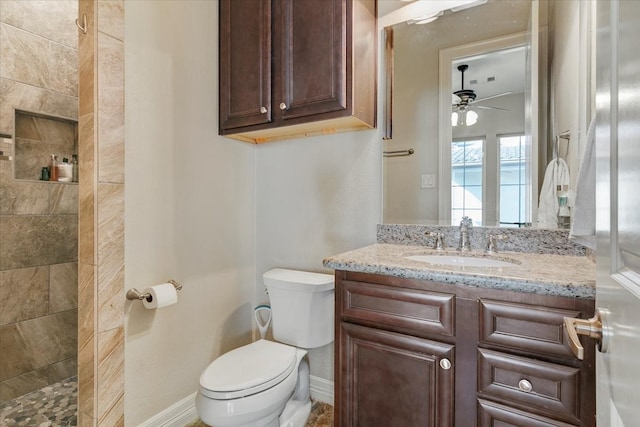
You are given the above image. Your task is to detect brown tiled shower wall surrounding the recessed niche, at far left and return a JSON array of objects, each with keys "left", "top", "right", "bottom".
[{"left": 0, "top": 0, "right": 78, "bottom": 400}]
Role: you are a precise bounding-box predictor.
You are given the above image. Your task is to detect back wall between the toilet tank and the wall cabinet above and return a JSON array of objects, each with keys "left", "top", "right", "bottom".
[{"left": 256, "top": 130, "right": 382, "bottom": 380}]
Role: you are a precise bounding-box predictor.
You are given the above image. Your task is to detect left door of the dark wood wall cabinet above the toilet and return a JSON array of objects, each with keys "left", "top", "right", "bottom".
[{"left": 219, "top": 0, "right": 272, "bottom": 133}]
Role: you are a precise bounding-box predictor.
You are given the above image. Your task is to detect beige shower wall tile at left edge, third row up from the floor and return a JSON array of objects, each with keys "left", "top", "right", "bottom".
[{"left": 0, "top": 266, "right": 49, "bottom": 325}]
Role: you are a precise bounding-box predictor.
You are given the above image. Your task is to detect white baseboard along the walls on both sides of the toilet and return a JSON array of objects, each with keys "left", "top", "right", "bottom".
[{"left": 139, "top": 375, "right": 333, "bottom": 427}]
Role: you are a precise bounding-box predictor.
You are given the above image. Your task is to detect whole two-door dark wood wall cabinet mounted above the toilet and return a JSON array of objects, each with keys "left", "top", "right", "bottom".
[{"left": 219, "top": 0, "right": 378, "bottom": 143}]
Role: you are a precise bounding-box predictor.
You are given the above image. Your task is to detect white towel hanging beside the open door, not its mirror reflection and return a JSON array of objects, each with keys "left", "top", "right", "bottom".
[{"left": 569, "top": 117, "right": 596, "bottom": 249}]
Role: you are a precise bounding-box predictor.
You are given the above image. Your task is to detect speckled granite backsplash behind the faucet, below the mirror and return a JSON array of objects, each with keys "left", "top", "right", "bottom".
[{"left": 377, "top": 224, "right": 586, "bottom": 256}]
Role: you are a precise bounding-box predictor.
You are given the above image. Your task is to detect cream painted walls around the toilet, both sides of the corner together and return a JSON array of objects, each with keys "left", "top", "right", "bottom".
[{"left": 125, "top": 1, "right": 382, "bottom": 425}]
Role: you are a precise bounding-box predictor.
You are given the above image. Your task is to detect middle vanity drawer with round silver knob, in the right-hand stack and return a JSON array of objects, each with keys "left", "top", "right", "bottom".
[{"left": 478, "top": 349, "right": 580, "bottom": 423}]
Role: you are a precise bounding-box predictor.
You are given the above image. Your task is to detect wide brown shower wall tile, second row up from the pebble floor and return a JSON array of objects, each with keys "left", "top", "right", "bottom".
[{"left": 0, "top": 310, "right": 78, "bottom": 381}]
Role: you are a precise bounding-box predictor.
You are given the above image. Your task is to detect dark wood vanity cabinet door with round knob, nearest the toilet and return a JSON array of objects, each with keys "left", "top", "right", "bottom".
[{"left": 335, "top": 322, "right": 454, "bottom": 427}]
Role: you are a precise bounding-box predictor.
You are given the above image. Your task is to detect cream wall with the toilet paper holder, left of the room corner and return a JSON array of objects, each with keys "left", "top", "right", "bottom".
[{"left": 123, "top": 1, "right": 256, "bottom": 426}]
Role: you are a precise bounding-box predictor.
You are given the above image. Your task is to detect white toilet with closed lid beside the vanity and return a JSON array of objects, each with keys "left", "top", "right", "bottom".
[{"left": 196, "top": 268, "right": 334, "bottom": 427}]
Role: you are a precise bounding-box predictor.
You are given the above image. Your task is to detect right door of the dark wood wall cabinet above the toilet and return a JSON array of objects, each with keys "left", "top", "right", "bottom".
[{"left": 274, "top": 0, "right": 352, "bottom": 121}]
